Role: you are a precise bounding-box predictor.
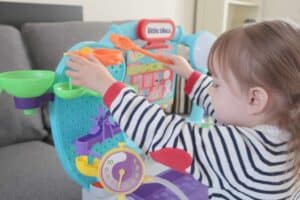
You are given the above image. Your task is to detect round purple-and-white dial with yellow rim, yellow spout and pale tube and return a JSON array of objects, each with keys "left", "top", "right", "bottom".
[{"left": 76, "top": 143, "right": 188, "bottom": 200}]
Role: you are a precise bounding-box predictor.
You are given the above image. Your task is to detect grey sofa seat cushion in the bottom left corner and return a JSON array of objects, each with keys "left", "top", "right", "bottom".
[{"left": 0, "top": 141, "right": 81, "bottom": 200}]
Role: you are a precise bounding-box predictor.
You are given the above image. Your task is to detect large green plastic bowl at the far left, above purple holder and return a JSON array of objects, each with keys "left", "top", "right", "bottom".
[{"left": 0, "top": 70, "right": 55, "bottom": 98}]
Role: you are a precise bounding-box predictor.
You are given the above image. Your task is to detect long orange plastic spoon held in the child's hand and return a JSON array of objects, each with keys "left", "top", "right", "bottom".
[{"left": 109, "top": 34, "right": 173, "bottom": 65}]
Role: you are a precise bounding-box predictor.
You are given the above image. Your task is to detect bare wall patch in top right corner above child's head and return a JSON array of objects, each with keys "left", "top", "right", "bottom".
[{"left": 263, "top": 0, "right": 300, "bottom": 23}]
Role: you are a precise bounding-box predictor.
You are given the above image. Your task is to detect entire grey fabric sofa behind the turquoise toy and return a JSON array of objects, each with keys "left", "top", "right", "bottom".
[{"left": 0, "top": 22, "right": 116, "bottom": 200}]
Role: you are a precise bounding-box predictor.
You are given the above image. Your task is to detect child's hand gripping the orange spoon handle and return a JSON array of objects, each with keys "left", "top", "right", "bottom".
[{"left": 165, "top": 55, "right": 194, "bottom": 79}]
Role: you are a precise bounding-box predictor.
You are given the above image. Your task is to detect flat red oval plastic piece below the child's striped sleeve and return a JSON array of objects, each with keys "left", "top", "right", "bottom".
[{"left": 150, "top": 148, "right": 192, "bottom": 173}]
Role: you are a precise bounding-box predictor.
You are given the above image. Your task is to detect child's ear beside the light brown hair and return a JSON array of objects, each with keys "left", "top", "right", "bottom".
[{"left": 247, "top": 87, "right": 269, "bottom": 115}]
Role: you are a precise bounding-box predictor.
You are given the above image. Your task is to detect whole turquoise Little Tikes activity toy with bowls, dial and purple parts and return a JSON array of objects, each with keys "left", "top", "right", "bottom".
[{"left": 0, "top": 19, "right": 215, "bottom": 200}]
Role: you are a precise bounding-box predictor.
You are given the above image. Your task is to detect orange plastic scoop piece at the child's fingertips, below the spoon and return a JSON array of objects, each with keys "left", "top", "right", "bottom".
[{"left": 73, "top": 47, "right": 123, "bottom": 67}]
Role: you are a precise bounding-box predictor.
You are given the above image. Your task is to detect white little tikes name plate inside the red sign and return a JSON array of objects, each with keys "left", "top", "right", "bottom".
[{"left": 146, "top": 23, "right": 173, "bottom": 39}]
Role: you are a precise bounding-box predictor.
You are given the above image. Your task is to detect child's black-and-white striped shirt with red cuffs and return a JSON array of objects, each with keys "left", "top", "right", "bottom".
[{"left": 104, "top": 72, "right": 295, "bottom": 200}]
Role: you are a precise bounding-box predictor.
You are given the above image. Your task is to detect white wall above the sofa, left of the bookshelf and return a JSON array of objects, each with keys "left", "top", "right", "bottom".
[{"left": 0, "top": 0, "right": 195, "bottom": 33}]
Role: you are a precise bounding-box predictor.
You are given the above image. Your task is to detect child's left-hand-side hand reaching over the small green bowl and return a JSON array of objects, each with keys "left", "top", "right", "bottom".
[{"left": 66, "top": 53, "right": 116, "bottom": 95}]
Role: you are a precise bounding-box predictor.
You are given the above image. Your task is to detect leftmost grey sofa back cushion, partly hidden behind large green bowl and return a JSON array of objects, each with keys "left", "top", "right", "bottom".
[{"left": 0, "top": 25, "right": 47, "bottom": 147}]
